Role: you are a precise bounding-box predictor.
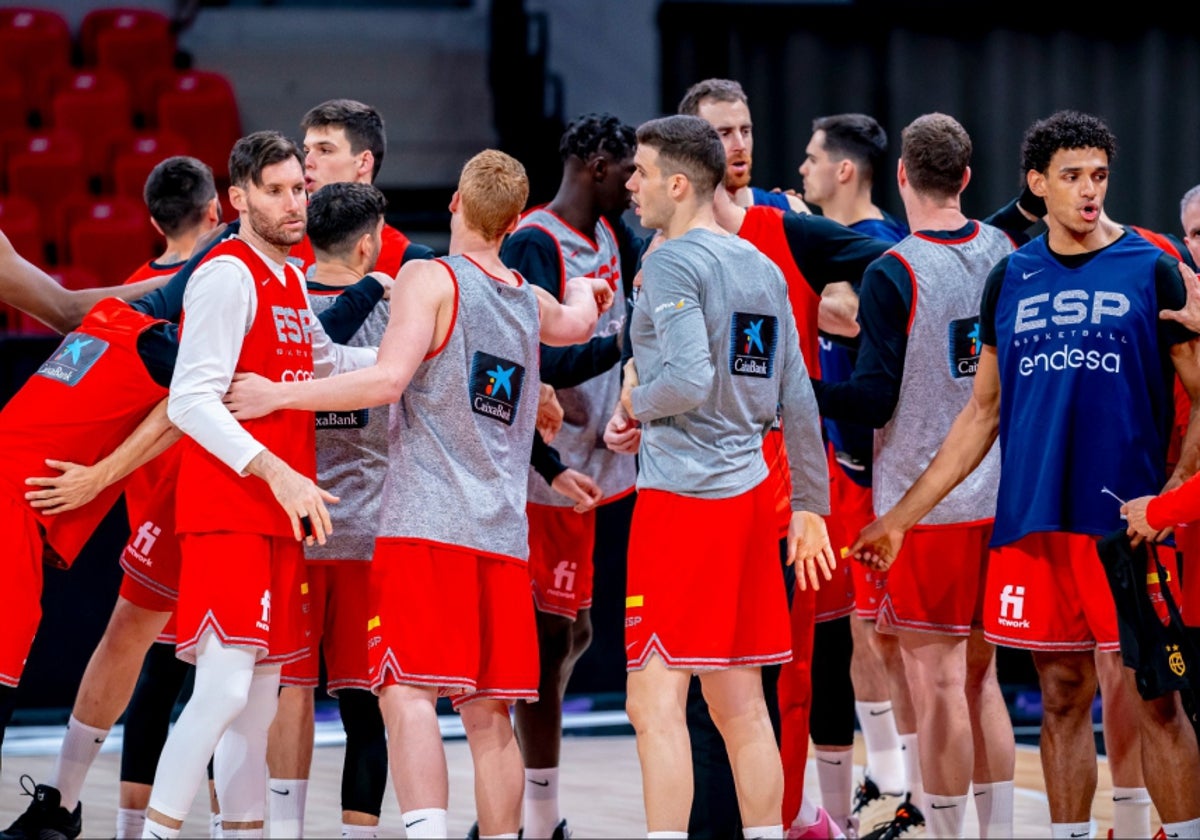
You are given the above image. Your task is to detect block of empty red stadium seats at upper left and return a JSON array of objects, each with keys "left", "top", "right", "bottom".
[{"left": 0, "top": 6, "right": 241, "bottom": 330}]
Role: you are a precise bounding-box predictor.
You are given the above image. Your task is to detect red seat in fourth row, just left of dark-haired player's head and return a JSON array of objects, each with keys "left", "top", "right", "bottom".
[{"left": 60, "top": 197, "right": 155, "bottom": 286}]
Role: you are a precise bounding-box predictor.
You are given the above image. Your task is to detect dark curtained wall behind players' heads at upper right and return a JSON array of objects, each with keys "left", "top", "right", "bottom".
[{"left": 659, "top": 0, "right": 1200, "bottom": 233}]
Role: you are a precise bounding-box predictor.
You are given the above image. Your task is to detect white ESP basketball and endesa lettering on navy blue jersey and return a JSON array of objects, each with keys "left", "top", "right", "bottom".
[{"left": 1013, "top": 289, "right": 1129, "bottom": 377}]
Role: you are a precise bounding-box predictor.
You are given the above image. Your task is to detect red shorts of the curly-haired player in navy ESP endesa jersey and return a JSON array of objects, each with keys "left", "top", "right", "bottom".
[{"left": 983, "top": 532, "right": 1121, "bottom": 652}]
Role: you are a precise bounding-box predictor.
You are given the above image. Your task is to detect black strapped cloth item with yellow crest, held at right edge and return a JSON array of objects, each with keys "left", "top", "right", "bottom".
[{"left": 1097, "top": 530, "right": 1200, "bottom": 726}]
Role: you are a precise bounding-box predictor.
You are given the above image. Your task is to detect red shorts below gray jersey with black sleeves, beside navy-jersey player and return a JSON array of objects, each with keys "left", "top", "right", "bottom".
[{"left": 876, "top": 520, "right": 991, "bottom": 636}]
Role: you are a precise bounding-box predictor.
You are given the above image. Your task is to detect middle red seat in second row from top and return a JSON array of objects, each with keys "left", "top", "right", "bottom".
[{"left": 50, "top": 68, "right": 133, "bottom": 193}]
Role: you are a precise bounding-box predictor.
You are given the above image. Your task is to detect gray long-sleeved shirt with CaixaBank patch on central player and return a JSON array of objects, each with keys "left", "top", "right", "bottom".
[{"left": 630, "top": 229, "right": 829, "bottom": 515}]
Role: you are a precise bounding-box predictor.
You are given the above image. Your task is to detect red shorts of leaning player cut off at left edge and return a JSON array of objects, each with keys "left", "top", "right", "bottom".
[{"left": 0, "top": 494, "right": 43, "bottom": 688}]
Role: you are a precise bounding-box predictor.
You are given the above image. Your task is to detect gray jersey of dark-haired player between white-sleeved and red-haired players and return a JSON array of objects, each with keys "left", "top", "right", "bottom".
[{"left": 304, "top": 286, "right": 391, "bottom": 560}]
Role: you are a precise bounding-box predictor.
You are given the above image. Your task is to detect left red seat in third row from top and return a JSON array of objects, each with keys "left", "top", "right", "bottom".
[{"left": 6, "top": 130, "right": 88, "bottom": 254}]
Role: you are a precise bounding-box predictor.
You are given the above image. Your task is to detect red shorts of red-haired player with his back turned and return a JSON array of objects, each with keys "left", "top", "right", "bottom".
[{"left": 367, "top": 538, "right": 539, "bottom": 708}]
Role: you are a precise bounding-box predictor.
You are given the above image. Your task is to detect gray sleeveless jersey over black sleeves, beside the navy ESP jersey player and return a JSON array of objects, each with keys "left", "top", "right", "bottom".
[{"left": 871, "top": 224, "right": 1013, "bottom": 524}]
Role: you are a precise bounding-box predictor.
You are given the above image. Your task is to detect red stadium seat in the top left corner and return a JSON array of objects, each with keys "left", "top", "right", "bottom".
[{"left": 0, "top": 6, "right": 72, "bottom": 126}]
